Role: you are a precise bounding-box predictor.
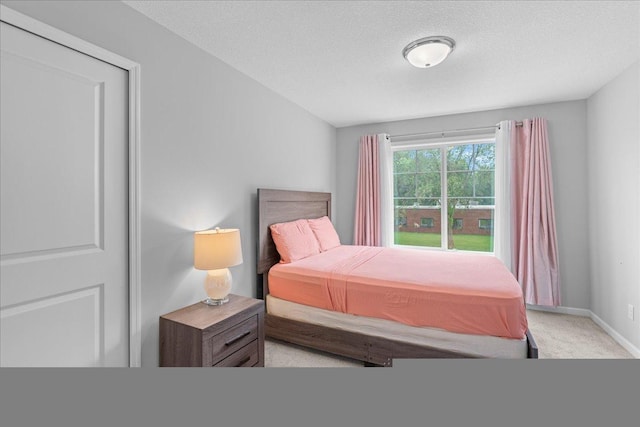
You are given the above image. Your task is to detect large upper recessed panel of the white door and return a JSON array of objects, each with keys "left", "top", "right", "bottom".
[{"left": 1, "top": 52, "right": 104, "bottom": 258}]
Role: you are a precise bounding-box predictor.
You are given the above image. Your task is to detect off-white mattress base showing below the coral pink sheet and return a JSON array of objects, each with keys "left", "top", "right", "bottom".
[{"left": 266, "top": 295, "right": 527, "bottom": 359}]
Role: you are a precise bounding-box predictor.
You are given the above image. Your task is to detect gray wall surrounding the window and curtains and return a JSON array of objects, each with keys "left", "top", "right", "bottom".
[{"left": 336, "top": 101, "right": 590, "bottom": 309}]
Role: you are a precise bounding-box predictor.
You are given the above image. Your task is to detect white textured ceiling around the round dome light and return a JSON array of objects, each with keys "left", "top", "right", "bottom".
[{"left": 124, "top": 1, "right": 640, "bottom": 127}]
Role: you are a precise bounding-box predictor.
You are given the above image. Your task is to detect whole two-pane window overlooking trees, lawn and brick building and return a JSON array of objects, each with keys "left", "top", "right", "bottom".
[{"left": 392, "top": 138, "right": 495, "bottom": 252}]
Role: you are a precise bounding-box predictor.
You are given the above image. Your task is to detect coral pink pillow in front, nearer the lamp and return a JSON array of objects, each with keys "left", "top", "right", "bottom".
[{"left": 269, "top": 219, "right": 320, "bottom": 263}]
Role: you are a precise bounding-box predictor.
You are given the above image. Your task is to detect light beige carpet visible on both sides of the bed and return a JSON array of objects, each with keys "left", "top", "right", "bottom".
[{"left": 265, "top": 310, "right": 634, "bottom": 367}]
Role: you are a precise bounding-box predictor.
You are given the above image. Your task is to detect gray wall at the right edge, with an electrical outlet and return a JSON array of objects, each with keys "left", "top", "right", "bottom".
[{"left": 587, "top": 62, "right": 640, "bottom": 348}]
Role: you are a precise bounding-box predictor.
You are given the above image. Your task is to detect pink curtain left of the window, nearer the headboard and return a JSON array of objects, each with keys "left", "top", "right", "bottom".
[{"left": 353, "top": 135, "right": 382, "bottom": 246}]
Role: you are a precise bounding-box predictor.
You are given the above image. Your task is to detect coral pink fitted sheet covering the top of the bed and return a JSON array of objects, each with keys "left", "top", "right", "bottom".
[{"left": 268, "top": 245, "right": 527, "bottom": 339}]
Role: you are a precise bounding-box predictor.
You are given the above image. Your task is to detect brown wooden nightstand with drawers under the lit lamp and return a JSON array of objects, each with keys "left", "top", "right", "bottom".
[{"left": 160, "top": 294, "right": 264, "bottom": 367}]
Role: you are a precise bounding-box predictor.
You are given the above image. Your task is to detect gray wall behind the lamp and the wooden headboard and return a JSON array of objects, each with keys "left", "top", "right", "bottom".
[{"left": 3, "top": 1, "right": 336, "bottom": 366}]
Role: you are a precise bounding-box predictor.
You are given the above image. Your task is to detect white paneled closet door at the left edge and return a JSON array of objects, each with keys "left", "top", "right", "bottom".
[{"left": 0, "top": 22, "right": 129, "bottom": 367}]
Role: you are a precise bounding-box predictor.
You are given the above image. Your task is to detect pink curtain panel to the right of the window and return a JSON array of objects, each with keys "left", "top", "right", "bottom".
[{"left": 510, "top": 118, "right": 560, "bottom": 306}]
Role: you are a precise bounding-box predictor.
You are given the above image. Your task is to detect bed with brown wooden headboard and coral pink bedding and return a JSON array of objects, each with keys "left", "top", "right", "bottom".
[{"left": 257, "top": 188, "right": 538, "bottom": 366}]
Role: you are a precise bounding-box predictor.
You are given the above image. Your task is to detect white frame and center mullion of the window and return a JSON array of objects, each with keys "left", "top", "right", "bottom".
[{"left": 389, "top": 132, "right": 502, "bottom": 256}]
